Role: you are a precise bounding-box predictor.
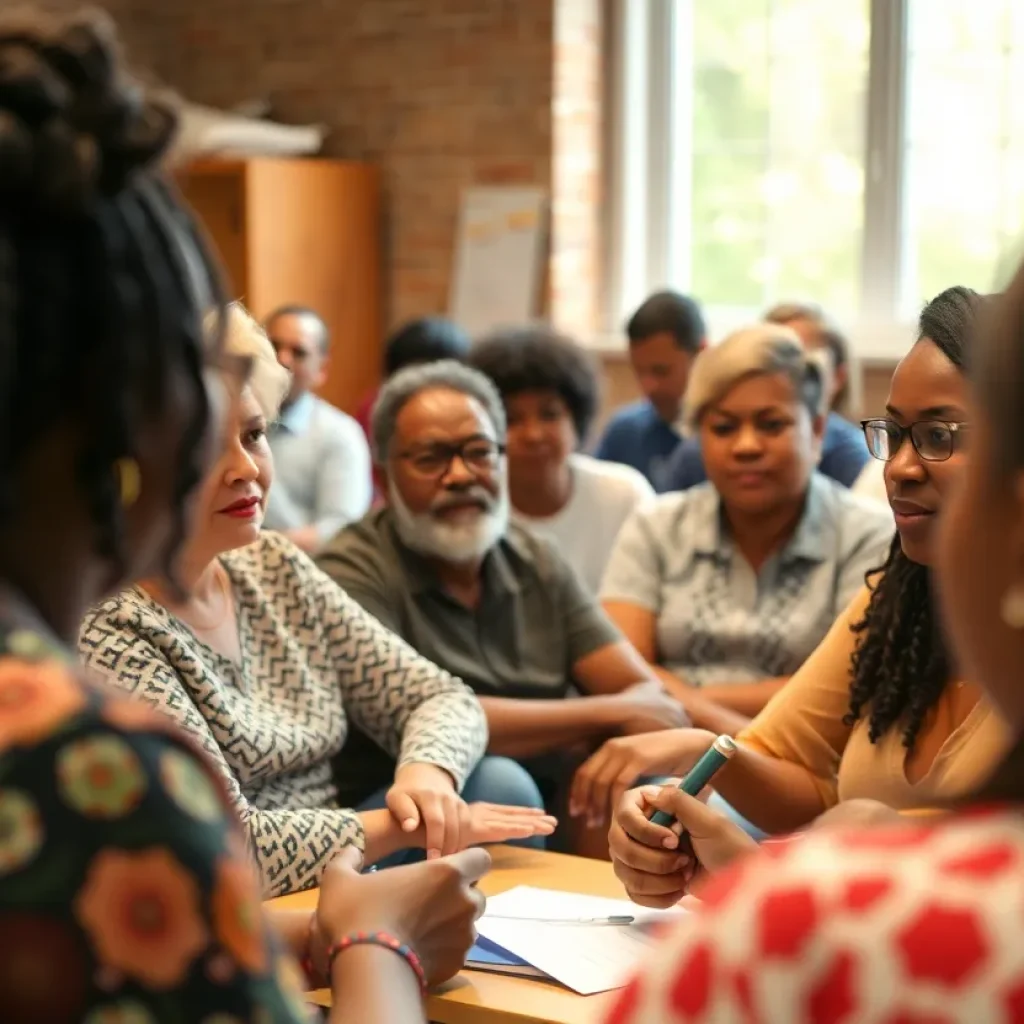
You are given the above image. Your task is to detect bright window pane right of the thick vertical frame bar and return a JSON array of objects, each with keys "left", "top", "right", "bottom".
[{"left": 903, "top": 0, "right": 1024, "bottom": 311}]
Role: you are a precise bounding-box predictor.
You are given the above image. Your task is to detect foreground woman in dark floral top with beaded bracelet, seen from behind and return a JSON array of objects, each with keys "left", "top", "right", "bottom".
[{"left": 0, "top": 11, "right": 520, "bottom": 1024}]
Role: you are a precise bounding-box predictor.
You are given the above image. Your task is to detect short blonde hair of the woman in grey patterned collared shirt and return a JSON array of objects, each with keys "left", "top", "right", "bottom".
[{"left": 683, "top": 324, "right": 825, "bottom": 430}]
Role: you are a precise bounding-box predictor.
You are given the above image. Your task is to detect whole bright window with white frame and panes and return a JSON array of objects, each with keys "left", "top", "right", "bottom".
[{"left": 608, "top": 0, "right": 1024, "bottom": 356}]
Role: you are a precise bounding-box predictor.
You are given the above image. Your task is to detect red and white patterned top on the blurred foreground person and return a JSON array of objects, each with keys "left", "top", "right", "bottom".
[{"left": 605, "top": 811, "right": 1024, "bottom": 1024}]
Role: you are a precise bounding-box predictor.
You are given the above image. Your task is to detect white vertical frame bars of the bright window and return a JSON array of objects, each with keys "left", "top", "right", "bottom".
[{"left": 596, "top": 0, "right": 914, "bottom": 368}]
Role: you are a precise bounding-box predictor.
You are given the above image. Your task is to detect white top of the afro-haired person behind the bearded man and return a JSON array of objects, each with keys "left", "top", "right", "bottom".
[{"left": 512, "top": 453, "right": 654, "bottom": 594}]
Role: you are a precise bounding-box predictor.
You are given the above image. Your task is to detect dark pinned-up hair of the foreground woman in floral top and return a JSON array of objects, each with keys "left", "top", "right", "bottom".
[{"left": 0, "top": 11, "right": 225, "bottom": 585}]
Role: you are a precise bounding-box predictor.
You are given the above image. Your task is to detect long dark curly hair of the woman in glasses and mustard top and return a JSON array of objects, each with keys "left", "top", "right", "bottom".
[{"left": 844, "top": 287, "right": 981, "bottom": 750}]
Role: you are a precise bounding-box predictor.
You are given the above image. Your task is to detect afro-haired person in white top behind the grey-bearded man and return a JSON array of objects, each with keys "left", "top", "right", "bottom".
[{"left": 469, "top": 319, "right": 654, "bottom": 593}]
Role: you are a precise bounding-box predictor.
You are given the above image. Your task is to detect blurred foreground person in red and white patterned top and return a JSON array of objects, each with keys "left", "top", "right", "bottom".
[{"left": 606, "top": 245, "right": 1024, "bottom": 1024}]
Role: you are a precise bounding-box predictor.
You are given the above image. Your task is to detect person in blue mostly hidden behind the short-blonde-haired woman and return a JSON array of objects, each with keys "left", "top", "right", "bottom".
[{"left": 658, "top": 302, "right": 870, "bottom": 492}]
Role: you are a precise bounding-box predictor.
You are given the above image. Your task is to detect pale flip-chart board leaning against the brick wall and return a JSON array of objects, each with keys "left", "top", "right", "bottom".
[{"left": 449, "top": 185, "right": 548, "bottom": 338}]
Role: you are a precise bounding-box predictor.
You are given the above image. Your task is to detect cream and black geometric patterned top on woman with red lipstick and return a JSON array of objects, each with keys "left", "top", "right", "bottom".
[{"left": 79, "top": 531, "right": 487, "bottom": 897}]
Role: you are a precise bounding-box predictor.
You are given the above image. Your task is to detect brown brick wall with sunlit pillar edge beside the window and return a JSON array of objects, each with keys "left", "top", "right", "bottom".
[{"left": 41, "top": 0, "right": 602, "bottom": 332}]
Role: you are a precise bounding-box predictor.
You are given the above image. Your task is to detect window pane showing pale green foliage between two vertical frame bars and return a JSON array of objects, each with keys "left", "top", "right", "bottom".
[{"left": 679, "top": 0, "right": 869, "bottom": 313}]
